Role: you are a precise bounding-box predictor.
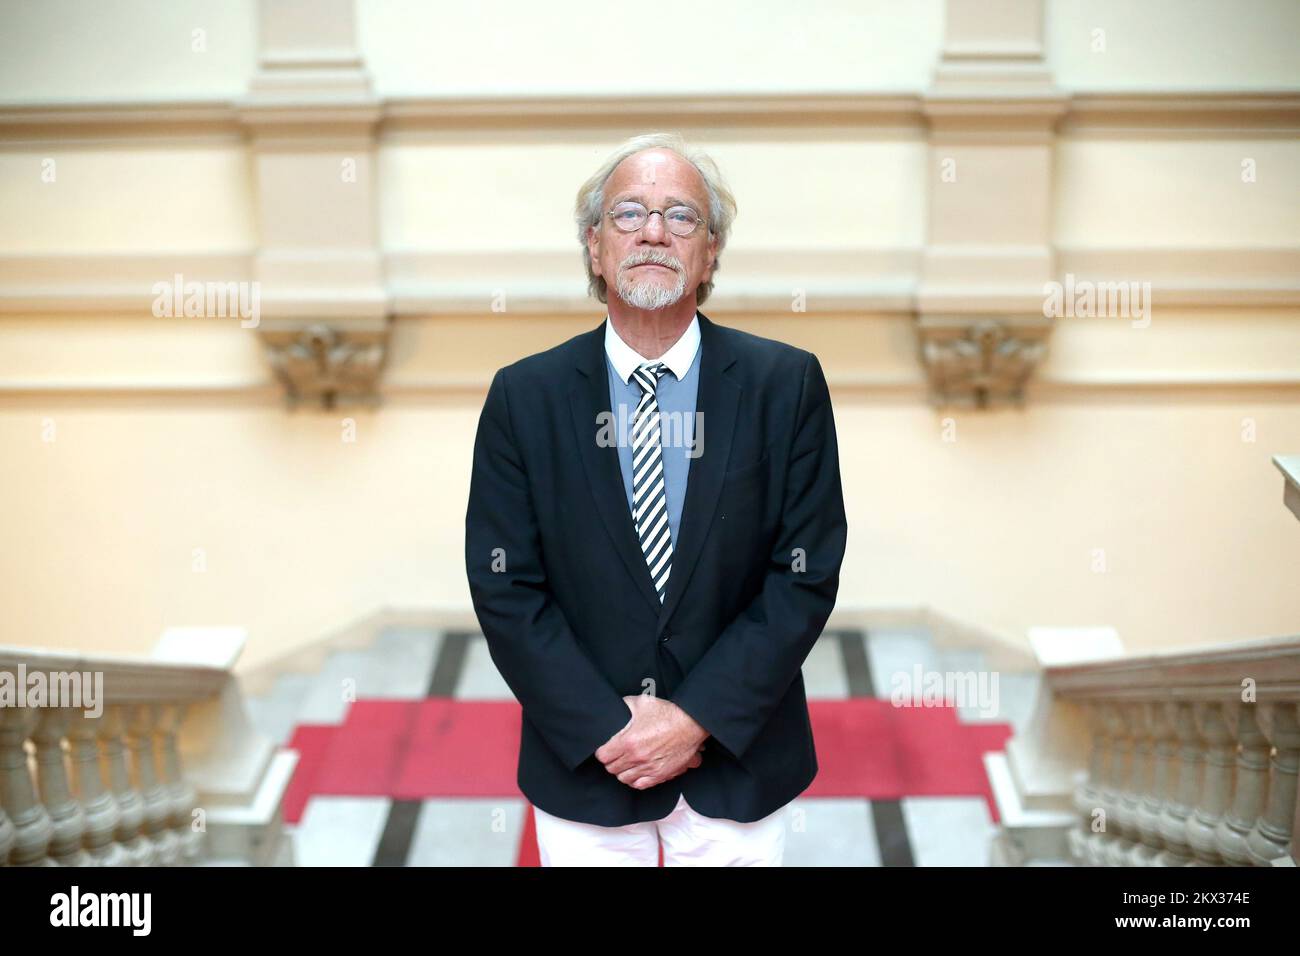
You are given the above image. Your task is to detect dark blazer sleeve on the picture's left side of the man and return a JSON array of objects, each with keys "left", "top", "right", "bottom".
[{"left": 465, "top": 369, "right": 632, "bottom": 770}]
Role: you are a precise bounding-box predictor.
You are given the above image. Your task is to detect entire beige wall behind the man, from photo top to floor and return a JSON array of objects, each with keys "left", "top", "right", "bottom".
[{"left": 0, "top": 0, "right": 1300, "bottom": 665}]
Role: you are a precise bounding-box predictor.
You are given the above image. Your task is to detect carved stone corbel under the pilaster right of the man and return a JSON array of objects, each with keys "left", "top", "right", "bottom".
[{"left": 917, "top": 316, "right": 1052, "bottom": 408}]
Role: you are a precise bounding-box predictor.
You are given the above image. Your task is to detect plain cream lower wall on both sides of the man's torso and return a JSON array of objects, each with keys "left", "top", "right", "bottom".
[{"left": 0, "top": 313, "right": 1300, "bottom": 665}]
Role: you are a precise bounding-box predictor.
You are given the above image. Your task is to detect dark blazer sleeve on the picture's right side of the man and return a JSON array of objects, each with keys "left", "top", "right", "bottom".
[{"left": 672, "top": 352, "right": 848, "bottom": 760}]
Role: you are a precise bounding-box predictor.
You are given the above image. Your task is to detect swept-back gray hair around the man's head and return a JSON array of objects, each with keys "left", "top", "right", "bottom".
[{"left": 575, "top": 133, "right": 736, "bottom": 304}]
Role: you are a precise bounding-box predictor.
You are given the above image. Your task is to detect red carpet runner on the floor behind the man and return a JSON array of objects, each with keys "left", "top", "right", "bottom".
[{"left": 285, "top": 697, "right": 1011, "bottom": 866}]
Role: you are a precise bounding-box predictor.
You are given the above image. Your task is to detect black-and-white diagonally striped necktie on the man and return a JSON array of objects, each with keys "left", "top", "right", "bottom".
[{"left": 632, "top": 362, "right": 672, "bottom": 604}]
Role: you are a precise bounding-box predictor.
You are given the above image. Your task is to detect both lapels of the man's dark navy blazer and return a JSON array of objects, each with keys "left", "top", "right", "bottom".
[{"left": 569, "top": 312, "right": 741, "bottom": 637}]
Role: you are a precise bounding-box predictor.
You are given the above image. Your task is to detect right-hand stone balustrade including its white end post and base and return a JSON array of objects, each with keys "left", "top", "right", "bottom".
[{"left": 985, "top": 628, "right": 1300, "bottom": 866}]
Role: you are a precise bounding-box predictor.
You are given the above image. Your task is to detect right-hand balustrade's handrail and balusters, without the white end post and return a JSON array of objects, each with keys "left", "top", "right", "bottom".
[{"left": 1047, "top": 637, "right": 1300, "bottom": 866}]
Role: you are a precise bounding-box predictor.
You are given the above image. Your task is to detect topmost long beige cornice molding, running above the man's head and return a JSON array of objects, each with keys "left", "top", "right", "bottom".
[{"left": 0, "top": 86, "right": 1300, "bottom": 143}]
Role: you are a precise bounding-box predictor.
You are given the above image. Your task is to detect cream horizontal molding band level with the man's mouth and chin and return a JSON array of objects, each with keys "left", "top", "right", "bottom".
[{"left": 0, "top": 247, "right": 1300, "bottom": 317}]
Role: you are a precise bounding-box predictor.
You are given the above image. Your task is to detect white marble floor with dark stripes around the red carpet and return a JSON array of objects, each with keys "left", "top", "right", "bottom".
[{"left": 248, "top": 628, "right": 1037, "bottom": 866}]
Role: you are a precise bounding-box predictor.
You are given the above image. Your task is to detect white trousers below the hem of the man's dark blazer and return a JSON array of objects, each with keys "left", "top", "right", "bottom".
[{"left": 533, "top": 795, "right": 789, "bottom": 866}]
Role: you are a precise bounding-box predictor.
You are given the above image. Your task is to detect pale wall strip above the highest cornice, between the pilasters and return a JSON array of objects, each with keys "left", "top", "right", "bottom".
[{"left": 0, "top": 0, "right": 1300, "bottom": 101}]
